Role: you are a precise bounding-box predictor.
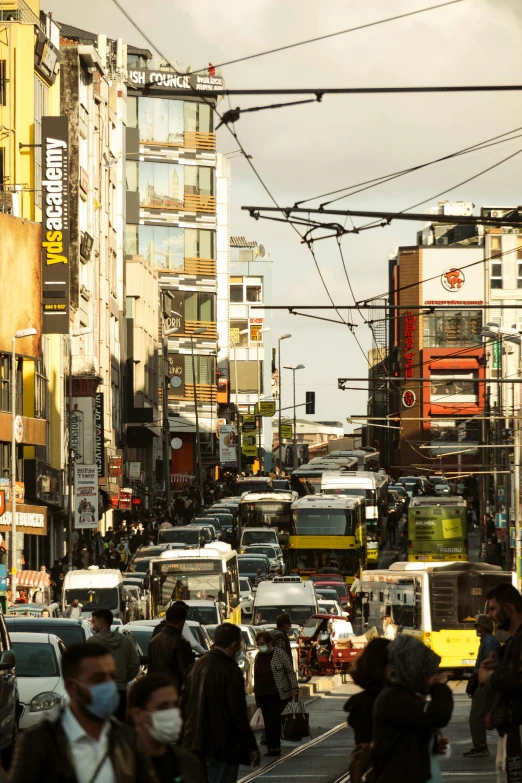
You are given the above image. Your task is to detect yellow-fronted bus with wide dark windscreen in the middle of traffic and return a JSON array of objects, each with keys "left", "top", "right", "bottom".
[{"left": 286, "top": 495, "right": 366, "bottom": 584}]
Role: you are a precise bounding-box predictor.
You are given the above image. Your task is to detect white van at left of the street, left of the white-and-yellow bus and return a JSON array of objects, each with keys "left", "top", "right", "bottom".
[{"left": 62, "top": 566, "right": 129, "bottom": 623}]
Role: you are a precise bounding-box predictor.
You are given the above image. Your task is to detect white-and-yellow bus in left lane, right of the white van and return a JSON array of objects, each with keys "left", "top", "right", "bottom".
[{"left": 149, "top": 547, "right": 241, "bottom": 625}]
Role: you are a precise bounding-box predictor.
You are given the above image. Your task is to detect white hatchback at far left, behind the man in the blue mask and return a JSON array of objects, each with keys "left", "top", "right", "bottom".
[{"left": 10, "top": 633, "right": 67, "bottom": 729}]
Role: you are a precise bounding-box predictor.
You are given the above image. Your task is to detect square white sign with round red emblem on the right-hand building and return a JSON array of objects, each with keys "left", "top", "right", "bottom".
[{"left": 421, "top": 247, "right": 485, "bottom": 307}]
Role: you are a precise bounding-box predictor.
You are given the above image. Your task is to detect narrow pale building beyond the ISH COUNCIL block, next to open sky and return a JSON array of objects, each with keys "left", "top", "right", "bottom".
[{"left": 229, "top": 237, "right": 272, "bottom": 471}]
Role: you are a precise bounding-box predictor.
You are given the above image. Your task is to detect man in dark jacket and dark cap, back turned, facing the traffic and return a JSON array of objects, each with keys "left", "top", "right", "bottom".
[{"left": 148, "top": 604, "right": 194, "bottom": 690}]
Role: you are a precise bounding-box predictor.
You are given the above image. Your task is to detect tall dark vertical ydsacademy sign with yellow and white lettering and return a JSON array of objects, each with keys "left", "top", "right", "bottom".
[{"left": 42, "top": 117, "right": 70, "bottom": 334}]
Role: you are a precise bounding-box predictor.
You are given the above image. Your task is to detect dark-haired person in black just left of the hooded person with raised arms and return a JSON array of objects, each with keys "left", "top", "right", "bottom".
[{"left": 344, "top": 636, "right": 390, "bottom": 745}]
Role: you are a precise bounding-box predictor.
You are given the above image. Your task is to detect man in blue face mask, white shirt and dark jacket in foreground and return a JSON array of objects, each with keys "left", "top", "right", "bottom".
[{"left": 8, "top": 644, "right": 157, "bottom": 783}]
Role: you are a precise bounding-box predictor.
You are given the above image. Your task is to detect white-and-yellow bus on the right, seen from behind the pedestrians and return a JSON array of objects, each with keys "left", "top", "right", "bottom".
[{"left": 353, "top": 562, "right": 516, "bottom": 674}]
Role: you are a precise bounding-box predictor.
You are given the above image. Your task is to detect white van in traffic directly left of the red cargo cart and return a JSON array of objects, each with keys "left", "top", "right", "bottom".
[{"left": 252, "top": 576, "right": 318, "bottom": 625}]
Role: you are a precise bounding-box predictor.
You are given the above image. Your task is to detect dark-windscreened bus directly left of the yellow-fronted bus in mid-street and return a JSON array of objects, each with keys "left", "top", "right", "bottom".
[{"left": 238, "top": 492, "right": 297, "bottom": 546}]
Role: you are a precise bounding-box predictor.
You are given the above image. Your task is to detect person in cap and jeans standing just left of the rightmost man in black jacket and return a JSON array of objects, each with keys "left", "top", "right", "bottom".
[{"left": 463, "top": 614, "right": 500, "bottom": 757}]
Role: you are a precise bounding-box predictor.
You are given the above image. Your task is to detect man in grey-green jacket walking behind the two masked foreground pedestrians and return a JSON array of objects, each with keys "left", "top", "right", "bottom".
[{"left": 87, "top": 609, "right": 140, "bottom": 721}]
